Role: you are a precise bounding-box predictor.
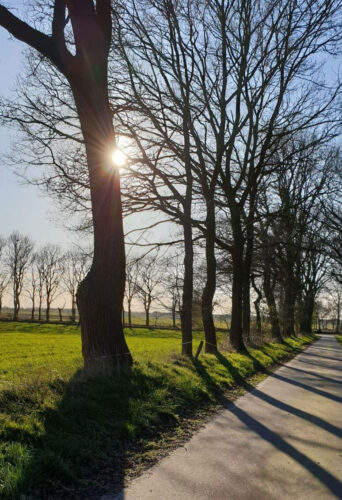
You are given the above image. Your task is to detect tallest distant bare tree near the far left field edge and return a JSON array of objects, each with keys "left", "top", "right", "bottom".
[{"left": 6, "top": 232, "right": 33, "bottom": 321}]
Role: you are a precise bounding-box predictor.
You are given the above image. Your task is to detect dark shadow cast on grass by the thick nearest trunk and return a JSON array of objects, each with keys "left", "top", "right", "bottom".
[{"left": 8, "top": 370, "right": 134, "bottom": 499}]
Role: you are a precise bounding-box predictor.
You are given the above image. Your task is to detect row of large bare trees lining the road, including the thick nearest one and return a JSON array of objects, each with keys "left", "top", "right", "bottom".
[{"left": 0, "top": 0, "right": 342, "bottom": 365}]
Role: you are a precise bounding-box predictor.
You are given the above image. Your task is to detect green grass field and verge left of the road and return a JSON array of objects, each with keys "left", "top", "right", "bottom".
[{"left": 0, "top": 323, "right": 313, "bottom": 498}]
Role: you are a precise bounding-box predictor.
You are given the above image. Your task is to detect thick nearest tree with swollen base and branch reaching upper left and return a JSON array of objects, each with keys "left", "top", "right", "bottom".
[{"left": 0, "top": 0, "right": 131, "bottom": 370}]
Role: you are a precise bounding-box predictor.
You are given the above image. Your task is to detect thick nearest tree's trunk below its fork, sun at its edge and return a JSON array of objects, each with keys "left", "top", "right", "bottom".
[{"left": 72, "top": 82, "right": 132, "bottom": 372}]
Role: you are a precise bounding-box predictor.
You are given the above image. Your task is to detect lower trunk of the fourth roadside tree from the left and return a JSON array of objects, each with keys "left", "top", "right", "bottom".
[{"left": 230, "top": 210, "right": 246, "bottom": 351}]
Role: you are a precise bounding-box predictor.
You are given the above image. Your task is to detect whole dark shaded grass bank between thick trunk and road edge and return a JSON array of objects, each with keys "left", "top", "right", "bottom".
[{"left": 0, "top": 366, "right": 184, "bottom": 499}]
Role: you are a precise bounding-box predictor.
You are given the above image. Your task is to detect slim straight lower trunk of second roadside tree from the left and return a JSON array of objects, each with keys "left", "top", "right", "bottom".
[{"left": 181, "top": 200, "right": 194, "bottom": 356}]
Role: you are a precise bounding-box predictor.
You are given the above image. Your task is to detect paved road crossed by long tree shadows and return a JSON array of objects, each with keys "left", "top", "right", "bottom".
[{"left": 112, "top": 336, "right": 342, "bottom": 500}]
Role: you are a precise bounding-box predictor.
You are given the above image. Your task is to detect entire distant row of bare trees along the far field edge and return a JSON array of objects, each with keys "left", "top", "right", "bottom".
[{"left": 0, "top": 232, "right": 182, "bottom": 327}]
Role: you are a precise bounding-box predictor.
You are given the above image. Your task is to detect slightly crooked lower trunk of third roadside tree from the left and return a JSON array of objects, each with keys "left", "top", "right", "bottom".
[{"left": 202, "top": 199, "right": 217, "bottom": 353}]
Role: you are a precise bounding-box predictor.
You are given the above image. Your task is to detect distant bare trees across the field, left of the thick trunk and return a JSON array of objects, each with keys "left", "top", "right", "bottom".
[{"left": 0, "top": 232, "right": 90, "bottom": 321}]
